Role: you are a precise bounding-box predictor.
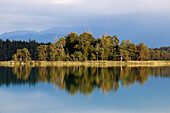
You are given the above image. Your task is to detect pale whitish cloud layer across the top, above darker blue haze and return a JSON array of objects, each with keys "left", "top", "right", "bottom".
[{"left": 0, "top": 0, "right": 170, "bottom": 33}]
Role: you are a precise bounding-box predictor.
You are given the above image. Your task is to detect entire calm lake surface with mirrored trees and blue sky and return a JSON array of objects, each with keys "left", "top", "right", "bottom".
[{"left": 0, "top": 66, "right": 170, "bottom": 113}]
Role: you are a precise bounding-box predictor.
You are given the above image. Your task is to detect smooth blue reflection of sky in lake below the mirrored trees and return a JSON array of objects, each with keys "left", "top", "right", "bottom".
[{"left": 0, "top": 77, "right": 170, "bottom": 113}]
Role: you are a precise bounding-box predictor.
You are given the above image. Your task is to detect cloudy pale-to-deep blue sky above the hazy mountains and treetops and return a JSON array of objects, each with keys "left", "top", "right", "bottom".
[{"left": 0, "top": 0, "right": 170, "bottom": 47}]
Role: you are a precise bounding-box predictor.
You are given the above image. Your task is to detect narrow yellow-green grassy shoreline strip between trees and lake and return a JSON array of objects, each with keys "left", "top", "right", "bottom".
[{"left": 0, "top": 61, "right": 170, "bottom": 66}]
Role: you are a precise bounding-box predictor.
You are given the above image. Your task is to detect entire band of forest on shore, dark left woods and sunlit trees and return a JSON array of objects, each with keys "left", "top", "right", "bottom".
[{"left": 0, "top": 32, "right": 170, "bottom": 62}]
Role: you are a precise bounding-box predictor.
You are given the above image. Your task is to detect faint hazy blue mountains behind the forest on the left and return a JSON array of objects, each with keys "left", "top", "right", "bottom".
[{"left": 0, "top": 27, "right": 99, "bottom": 43}]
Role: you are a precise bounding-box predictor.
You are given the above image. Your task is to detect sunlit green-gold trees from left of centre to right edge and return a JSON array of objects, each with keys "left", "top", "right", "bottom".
[{"left": 31, "top": 32, "right": 170, "bottom": 61}]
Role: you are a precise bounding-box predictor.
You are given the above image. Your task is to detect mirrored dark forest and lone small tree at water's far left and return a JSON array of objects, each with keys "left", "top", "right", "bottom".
[{"left": 0, "top": 66, "right": 38, "bottom": 86}]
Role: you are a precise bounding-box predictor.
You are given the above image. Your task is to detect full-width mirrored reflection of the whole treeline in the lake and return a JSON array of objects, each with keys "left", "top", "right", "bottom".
[{"left": 0, "top": 66, "right": 170, "bottom": 95}]
